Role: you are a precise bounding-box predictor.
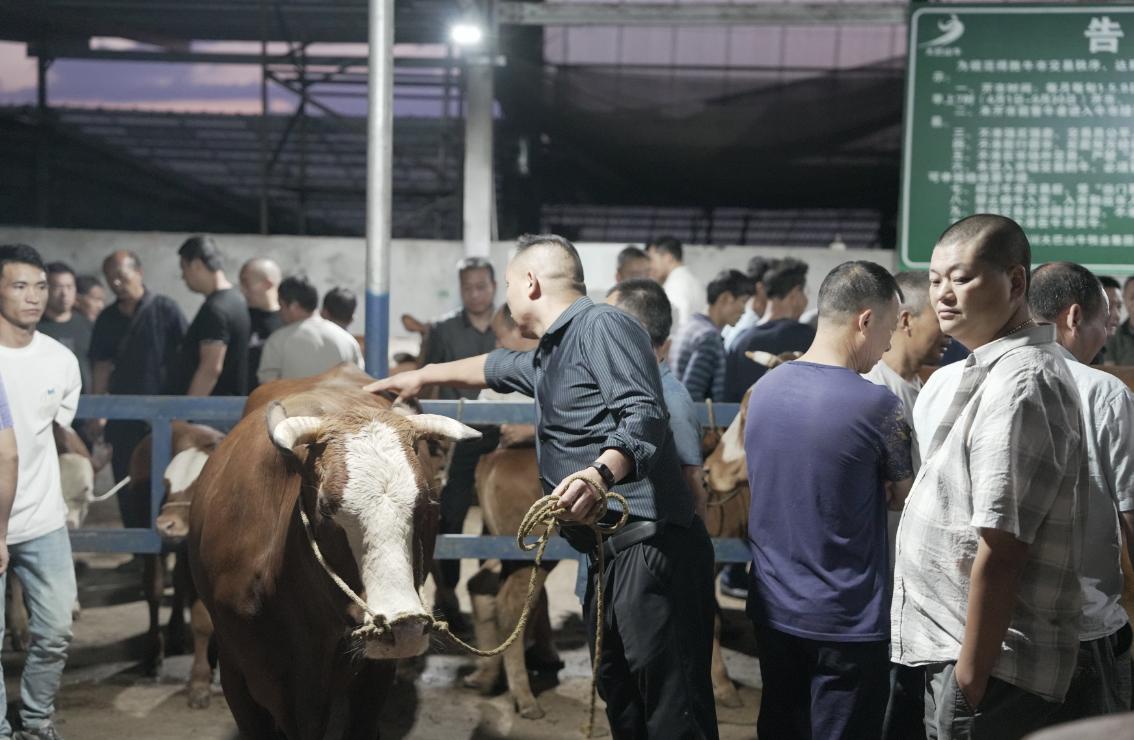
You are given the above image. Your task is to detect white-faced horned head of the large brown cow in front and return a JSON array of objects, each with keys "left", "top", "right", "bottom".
[{"left": 268, "top": 402, "right": 481, "bottom": 660}]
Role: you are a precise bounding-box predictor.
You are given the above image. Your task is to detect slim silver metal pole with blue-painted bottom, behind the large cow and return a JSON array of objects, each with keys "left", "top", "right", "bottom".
[{"left": 366, "top": 0, "right": 393, "bottom": 377}]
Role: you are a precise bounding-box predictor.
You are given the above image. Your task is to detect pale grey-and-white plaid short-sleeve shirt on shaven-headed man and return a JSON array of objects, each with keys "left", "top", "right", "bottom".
[{"left": 890, "top": 326, "right": 1089, "bottom": 701}]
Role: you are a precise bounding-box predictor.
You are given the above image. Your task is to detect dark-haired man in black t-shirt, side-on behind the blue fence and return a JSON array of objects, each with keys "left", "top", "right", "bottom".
[{"left": 170, "top": 236, "right": 252, "bottom": 395}]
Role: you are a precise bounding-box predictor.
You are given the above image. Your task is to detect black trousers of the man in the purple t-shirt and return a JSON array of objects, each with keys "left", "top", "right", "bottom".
[{"left": 756, "top": 623, "right": 890, "bottom": 740}]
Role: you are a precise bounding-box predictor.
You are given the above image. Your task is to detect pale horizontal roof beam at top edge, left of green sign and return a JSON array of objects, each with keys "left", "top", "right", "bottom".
[{"left": 497, "top": 1, "right": 908, "bottom": 26}]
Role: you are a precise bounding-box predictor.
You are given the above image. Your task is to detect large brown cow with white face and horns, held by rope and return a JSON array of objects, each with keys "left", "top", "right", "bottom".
[{"left": 188, "top": 368, "right": 479, "bottom": 740}]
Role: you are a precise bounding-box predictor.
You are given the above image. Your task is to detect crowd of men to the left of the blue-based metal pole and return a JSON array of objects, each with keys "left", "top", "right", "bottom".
[{"left": 0, "top": 236, "right": 363, "bottom": 740}]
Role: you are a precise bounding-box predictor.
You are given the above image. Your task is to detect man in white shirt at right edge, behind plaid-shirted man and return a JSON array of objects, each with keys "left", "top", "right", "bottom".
[{"left": 1027, "top": 262, "right": 1134, "bottom": 722}]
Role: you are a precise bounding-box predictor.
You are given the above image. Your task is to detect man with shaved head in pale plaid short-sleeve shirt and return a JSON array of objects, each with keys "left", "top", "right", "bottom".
[{"left": 890, "top": 214, "right": 1089, "bottom": 740}]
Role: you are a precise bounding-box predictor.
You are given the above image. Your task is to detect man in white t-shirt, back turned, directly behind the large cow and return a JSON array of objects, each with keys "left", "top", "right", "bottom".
[{"left": 256, "top": 277, "right": 363, "bottom": 383}]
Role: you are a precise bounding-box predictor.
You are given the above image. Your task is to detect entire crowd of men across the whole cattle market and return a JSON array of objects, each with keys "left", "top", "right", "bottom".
[{"left": 0, "top": 215, "right": 1134, "bottom": 739}]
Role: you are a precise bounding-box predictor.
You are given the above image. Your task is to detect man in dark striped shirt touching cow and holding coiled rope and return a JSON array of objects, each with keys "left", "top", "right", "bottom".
[{"left": 370, "top": 235, "right": 718, "bottom": 739}]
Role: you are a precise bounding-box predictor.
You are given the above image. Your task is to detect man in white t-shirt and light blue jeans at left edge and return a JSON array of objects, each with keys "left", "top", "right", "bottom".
[{"left": 0, "top": 245, "right": 82, "bottom": 740}]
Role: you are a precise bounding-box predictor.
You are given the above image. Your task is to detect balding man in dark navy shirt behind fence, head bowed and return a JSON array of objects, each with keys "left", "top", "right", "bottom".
[{"left": 91, "top": 250, "right": 187, "bottom": 527}]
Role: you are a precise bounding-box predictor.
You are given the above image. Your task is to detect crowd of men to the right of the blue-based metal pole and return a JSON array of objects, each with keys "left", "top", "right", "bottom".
[{"left": 383, "top": 225, "right": 1134, "bottom": 739}]
